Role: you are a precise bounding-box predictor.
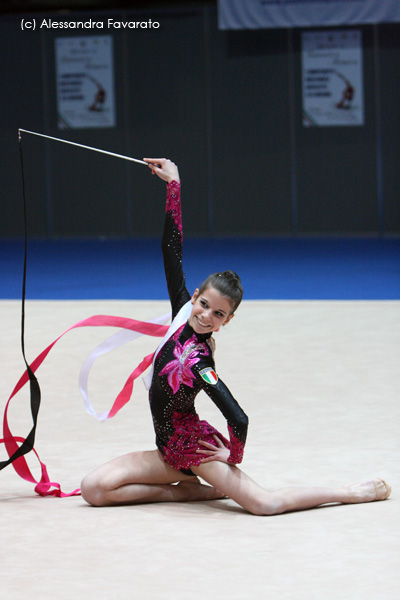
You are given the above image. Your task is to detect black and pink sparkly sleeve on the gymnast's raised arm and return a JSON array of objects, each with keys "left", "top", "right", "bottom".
[{"left": 161, "top": 181, "right": 190, "bottom": 317}]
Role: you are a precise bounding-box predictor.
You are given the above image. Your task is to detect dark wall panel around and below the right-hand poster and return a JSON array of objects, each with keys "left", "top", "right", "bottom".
[{"left": 294, "top": 27, "right": 378, "bottom": 233}]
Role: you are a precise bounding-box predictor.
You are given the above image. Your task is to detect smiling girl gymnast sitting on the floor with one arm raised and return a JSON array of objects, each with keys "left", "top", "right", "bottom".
[{"left": 81, "top": 159, "right": 391, "bottom": 515}]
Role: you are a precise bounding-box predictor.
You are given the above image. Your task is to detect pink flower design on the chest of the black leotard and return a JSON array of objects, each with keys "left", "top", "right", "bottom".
[{"left": 159, "top": 338, "right": 209, "bottom": 394}]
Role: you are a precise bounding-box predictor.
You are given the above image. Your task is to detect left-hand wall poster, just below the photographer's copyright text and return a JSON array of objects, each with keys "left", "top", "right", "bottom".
[{"left": 55, "top": 35, "right": 115, "bottom": 129}]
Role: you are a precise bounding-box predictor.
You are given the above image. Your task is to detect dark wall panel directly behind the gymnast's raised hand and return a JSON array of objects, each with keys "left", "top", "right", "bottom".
[{"left": 126, "top": 8, "right": 208, "bottom": 235}]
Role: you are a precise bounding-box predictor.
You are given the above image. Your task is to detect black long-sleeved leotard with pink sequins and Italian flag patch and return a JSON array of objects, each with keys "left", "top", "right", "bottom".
[{"left": 149, "top": 181, "right": 248, "bottom": 474}]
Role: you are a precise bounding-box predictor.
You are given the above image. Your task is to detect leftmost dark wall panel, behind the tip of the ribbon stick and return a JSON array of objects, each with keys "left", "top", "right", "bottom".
[{"left": 0, "top": 16, "right": 46, "bottom": 236}]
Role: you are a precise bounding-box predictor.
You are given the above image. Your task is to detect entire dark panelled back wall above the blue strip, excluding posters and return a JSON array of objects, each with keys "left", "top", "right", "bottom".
[{"left": 0, "top": 7, "right": 400, "bottom": 237}]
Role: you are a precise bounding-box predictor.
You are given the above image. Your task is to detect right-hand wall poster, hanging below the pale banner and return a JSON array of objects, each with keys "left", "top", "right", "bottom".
[{"left": 301, "top": 29, "right": 364, "bottom": 127}]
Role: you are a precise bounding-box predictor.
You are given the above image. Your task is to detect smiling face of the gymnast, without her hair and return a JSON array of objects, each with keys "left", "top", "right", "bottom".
[{"left": 189, "top": 286, "right": 234, "bottom": 333}]
